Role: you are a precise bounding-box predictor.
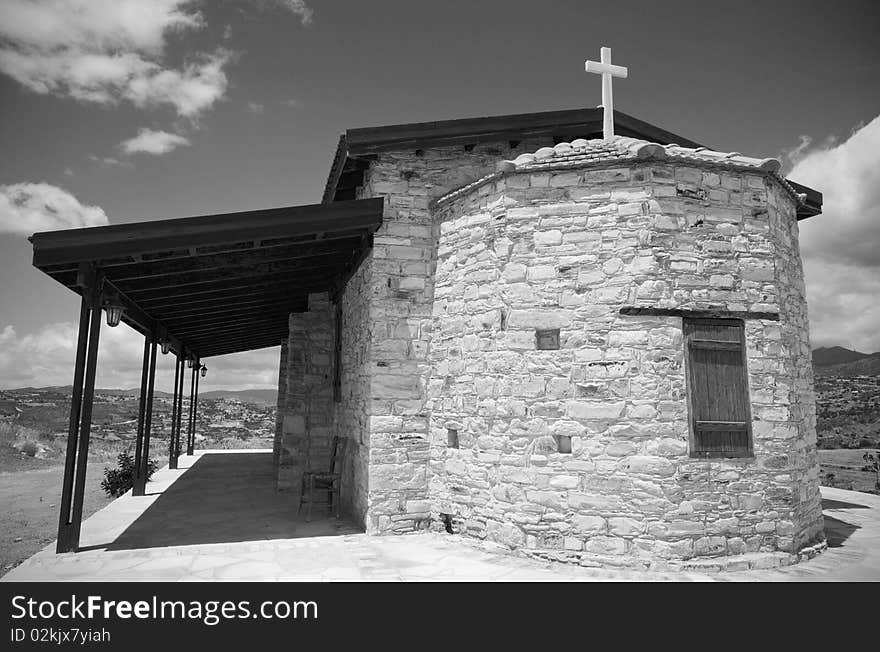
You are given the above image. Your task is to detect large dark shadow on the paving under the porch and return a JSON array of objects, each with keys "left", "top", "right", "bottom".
[{"left": 87, "top": 452, "right": 362, "bottom": 550}]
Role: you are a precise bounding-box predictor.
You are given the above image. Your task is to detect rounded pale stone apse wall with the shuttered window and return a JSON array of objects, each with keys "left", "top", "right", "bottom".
[{"left": 423, "top": 162, "right": 821, "bottom": 566}]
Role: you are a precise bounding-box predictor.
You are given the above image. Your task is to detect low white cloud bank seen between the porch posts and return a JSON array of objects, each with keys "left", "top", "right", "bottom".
[{"left": 0, "top": 322, "right": 279, "bottom": 392}]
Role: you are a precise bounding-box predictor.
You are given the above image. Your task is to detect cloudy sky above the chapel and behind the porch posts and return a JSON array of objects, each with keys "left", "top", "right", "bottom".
[{"left": 0, "top": 0, "right": 880, "bottom": 390}]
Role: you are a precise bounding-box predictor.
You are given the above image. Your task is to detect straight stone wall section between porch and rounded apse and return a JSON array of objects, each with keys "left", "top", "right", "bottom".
[{"left": 358, "top": 139, "right": 553, "bottom": 533}]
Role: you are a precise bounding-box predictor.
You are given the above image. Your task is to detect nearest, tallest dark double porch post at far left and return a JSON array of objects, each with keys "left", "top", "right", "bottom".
[{"left": 55, "top": 267, "right": 103, "bottom": 552}]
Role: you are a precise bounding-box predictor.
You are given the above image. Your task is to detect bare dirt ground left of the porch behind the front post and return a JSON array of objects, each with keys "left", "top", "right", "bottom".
[{"left": 0, "top": 462, "right": 111, "bottom": 574}]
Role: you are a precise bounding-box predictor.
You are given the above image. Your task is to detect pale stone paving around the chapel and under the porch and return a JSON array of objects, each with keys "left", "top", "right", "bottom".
[{"left": 2, "top": 451, "right": 880, "bottom": 581}]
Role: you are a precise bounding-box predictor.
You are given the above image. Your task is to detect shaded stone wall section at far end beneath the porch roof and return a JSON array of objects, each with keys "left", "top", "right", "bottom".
[{"left": 276, "top": 293, "right": 334, "bottom": 493}]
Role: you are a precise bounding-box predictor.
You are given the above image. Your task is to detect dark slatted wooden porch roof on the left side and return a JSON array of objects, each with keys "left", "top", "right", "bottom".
[{"left": 29, "top": 198, "right": 383, "bottom": 359}]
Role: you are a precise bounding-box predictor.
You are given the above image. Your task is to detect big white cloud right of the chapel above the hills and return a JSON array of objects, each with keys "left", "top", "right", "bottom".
[{"left": 788, "top": 116, "right": 880, "bottom": 353}]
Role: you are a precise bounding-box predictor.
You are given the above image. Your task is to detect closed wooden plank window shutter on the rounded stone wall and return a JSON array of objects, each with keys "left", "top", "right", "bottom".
[{"left": 684, "top": 318, "right": 752, "bottom": 457}]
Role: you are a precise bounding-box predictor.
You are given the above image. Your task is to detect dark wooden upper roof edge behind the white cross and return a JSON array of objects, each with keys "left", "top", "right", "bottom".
[{"left": 322, "top": 108, "right": 822, "bottom": 220}]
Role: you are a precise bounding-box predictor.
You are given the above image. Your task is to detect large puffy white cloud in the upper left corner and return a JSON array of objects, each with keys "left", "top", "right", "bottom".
[{"left": 0, "top": 0, "right": 231, "bottom": 119}]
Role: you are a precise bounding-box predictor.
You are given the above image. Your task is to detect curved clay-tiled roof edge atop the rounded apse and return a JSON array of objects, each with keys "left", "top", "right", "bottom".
[{"left": 437, "top": 136, "right": 822, "bottom": 219}]
